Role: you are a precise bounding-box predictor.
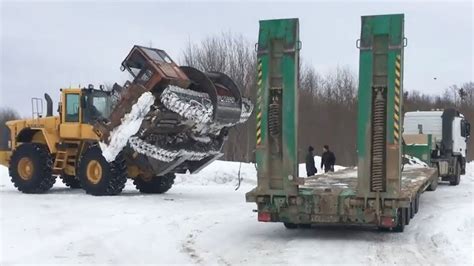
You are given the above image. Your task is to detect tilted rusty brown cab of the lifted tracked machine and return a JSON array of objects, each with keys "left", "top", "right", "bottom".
[{"left": 121, "top": 45, "right": 189, "bottom": 90}]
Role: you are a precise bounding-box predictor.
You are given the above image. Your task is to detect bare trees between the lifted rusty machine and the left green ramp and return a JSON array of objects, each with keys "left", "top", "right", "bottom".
[{"left": 182, "top": 33, "right": 256, "bottom": 161}]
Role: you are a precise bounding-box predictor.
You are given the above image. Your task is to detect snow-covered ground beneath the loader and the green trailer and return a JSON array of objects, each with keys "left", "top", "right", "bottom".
[{"left": 0, "top": 159, "right": 474, "bottom": 265}]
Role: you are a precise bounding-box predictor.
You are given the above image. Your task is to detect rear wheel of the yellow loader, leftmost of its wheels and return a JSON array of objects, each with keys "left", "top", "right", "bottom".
[{"left": 8, "top": 143, "right": 56, "bottom": 193}]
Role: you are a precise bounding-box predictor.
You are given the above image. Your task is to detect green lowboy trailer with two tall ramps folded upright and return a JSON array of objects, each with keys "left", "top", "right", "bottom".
[{"left": 246, "top": 14, "right": 438, "bottom": 231}]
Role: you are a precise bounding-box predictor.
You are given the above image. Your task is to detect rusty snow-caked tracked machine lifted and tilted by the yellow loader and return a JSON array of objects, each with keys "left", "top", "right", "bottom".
[{"left": 94, "top": 46, "right": 253, "bottom": 177}]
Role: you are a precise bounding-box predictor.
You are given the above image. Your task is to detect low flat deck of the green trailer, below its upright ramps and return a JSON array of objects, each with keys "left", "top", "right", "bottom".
[{"left": 246, "top": 166, "right": 437, "bottom": 228}]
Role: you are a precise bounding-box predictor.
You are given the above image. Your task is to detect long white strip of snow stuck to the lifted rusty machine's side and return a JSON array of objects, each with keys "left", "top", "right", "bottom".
[{"left": 99, "top": 92, "right": 155, "bottom": 162}]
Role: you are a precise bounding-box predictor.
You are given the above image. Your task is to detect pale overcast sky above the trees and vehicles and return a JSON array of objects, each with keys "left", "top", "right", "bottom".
[{"left": 0, "top": 1, "right": 474, "bottom": 116}]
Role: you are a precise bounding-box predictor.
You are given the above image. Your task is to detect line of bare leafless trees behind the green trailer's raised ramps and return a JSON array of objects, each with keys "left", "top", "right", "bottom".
[{"left": 181, "top": 33, "right": 474, "bottom": 165}]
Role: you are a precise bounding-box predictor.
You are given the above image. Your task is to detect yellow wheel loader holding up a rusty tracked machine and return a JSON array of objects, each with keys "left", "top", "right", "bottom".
[{"left": 0, "top": 88, "right": 128, "bottom": 195}]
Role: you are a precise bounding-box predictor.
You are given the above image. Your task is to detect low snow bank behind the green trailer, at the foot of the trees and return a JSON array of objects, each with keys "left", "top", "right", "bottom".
[{"left": 175, "top": 156, "right": 346, "bottom": 185}]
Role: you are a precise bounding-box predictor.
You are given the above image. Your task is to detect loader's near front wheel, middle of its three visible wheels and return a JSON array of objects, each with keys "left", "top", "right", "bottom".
[{"left": 78, "top": 145, "right": 127, "bottom": 196}]
